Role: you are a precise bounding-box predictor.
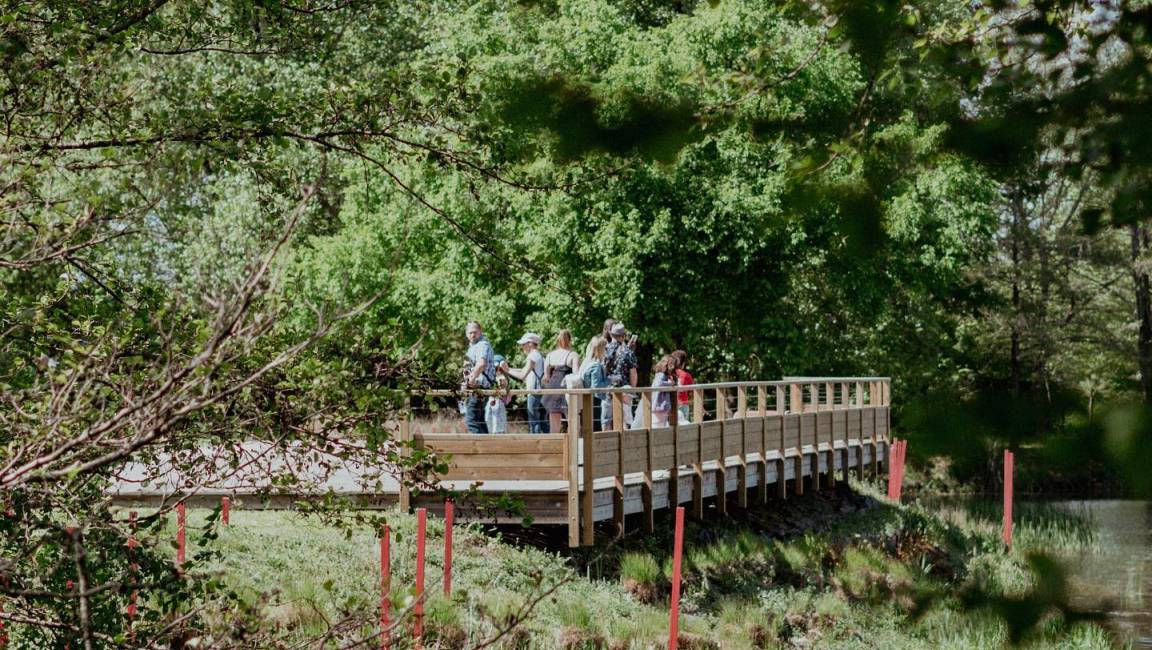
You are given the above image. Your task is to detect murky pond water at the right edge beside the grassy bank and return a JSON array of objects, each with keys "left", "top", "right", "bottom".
[{"left": 1049, "top": 500, "right": 1152, "bottom": 648}]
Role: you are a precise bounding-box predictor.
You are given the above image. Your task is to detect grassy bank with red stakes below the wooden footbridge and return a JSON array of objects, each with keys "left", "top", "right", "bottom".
[{"left": 162, "top": 479, "right": 1109, "bottom": 649}]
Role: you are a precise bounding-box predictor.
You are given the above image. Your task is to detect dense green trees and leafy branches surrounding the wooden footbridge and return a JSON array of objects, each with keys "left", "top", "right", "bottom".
[{"left": 0, "top": 0, "right": 1152, "bottom": 647}]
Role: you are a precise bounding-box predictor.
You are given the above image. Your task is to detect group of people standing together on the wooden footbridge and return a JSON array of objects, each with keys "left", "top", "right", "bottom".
[{"left": 461, "top": 319, "right": 695, "bottom": 433}]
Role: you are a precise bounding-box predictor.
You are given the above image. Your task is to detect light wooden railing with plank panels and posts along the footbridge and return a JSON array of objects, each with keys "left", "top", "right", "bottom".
[{"left": 400, "top": 377, "right": 890, "bottom": 546}]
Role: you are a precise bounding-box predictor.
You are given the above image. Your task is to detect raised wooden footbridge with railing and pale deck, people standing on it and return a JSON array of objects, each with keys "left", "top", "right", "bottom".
[{"left": 111, "top": 377, "right": 890, "bottom": 546}]
